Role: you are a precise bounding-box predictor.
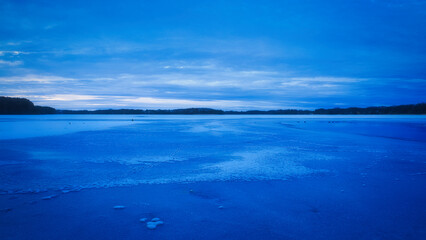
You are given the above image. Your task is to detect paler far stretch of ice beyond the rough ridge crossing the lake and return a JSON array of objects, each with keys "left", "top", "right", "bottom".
[{"left": 0, "top": 115, "right": 426, "bottom": 194}]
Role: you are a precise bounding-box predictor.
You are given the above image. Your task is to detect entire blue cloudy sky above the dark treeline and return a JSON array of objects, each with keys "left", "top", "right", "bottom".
[{"left": 0, "top": 0, "right": 426, "bottom": 110}]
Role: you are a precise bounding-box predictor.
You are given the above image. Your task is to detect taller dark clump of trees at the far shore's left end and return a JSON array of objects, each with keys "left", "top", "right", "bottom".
[{"left": 0, "top": 97, "right": 56, "bottom": 114}]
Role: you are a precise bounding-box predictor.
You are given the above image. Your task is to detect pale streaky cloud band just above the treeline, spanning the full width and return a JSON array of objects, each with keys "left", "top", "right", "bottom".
[{"left": 0, "top": 70, "right": 426, "bottom": 110}]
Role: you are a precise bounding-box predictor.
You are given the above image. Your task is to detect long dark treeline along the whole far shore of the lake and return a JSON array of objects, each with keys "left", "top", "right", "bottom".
[{"left": 0, "top": 97, "right": 426, "bottom": 115}]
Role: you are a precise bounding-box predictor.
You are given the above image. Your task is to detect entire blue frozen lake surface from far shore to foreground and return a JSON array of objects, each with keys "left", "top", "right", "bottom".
[{"left": 0, "top": 115, "right": 426, "bottom": 239}]
